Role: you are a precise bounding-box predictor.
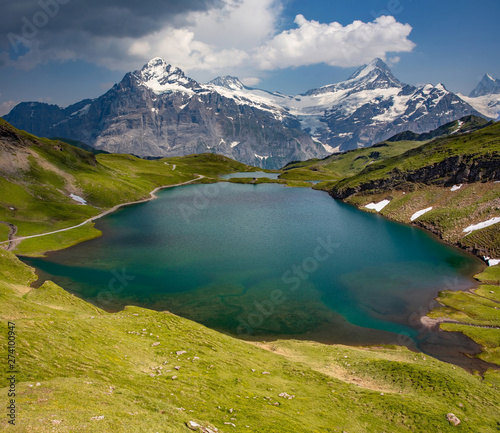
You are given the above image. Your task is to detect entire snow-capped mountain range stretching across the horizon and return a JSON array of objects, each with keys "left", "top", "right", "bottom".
[{"left": 4, "top": 58, "right": 498, "bottom": 168}]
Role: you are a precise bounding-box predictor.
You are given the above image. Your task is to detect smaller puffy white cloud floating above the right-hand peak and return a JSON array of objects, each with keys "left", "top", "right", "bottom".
[{"left": 255, "top": 15, "right": 415, "bottom": 70}]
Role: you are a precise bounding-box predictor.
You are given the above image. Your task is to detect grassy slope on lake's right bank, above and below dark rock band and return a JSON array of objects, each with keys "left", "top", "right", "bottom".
[{"left": 315, "top": 122, "right": 500, "bottom": 257}]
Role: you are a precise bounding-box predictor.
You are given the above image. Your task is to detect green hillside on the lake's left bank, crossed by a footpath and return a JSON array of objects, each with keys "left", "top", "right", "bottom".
[{"left": 0, "top": 119, "right": 252, "bottom": 255}]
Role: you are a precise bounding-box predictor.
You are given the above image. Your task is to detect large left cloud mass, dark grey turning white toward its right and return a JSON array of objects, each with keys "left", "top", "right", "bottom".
[{"left": 0, "top": 0, "right": 281, "bottom": 71}]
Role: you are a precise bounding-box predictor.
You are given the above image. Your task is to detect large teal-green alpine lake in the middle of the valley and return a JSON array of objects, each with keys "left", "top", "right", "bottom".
[{"left": 23, "top": 183, "right": 479, "bottom": 343}]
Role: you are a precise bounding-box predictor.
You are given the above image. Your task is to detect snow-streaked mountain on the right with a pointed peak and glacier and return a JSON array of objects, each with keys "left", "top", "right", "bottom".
[{"left": 272, "top": 59, "right": 479, "bottom": 150}]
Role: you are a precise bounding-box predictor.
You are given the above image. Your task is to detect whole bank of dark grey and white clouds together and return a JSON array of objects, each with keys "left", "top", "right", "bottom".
[{"left": 0, "top": 0, "right": 414, "bottom": 79}]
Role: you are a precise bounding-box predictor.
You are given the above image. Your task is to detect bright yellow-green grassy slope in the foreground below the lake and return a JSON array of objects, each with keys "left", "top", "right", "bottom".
[{"left": 0, "top": 251, "right": 500, "bottom": 433}]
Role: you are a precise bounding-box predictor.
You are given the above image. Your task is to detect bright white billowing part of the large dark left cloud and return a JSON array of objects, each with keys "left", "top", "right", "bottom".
[{"left": 121, "top": 0, "right": 281, "bottom": 72}]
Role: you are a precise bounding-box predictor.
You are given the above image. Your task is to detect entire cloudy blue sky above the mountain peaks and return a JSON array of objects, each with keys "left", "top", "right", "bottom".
[{"left": 0, "top": 0, "right": 500, "bottom": 114}]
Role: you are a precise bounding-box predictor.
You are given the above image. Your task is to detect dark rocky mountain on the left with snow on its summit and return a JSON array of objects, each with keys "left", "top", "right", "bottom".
[{"left": 5, "top": 58, "right": 328, "bottom": 168}]
